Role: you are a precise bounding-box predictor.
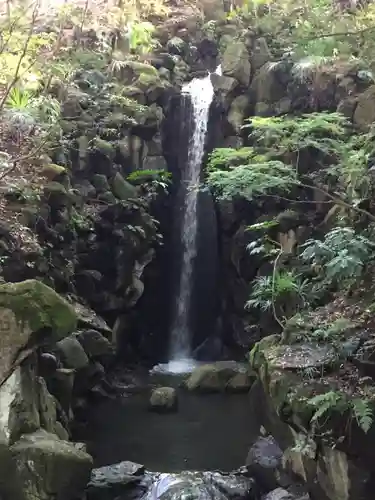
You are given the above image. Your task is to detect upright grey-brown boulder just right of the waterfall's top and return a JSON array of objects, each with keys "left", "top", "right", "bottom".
[{"left": 222, "top": 41, "right": 251, "bottom": 87}]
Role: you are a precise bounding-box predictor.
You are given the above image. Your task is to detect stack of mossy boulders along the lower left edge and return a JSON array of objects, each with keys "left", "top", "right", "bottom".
[{"left": 0, "top": 280, "right": 92, "bottom": 500}]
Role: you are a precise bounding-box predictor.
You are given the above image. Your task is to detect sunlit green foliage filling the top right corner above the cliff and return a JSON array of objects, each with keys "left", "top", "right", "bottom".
[{"left": 223, "top": 0, "right": 375, "bottom": 67}]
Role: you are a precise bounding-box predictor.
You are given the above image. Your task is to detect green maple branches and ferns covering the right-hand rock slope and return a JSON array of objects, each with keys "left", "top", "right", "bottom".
[{"left": 206, "top": 108, "right": 375, "bottom": 438}]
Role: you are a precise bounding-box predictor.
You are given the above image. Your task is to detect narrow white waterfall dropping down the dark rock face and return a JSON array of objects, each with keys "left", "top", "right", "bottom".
[{"left": 168, "top": 71, "right": 214, "bottom": 372}]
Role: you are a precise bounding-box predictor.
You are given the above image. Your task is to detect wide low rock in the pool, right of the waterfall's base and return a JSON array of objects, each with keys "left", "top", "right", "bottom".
[{"left": 185, "top": 361, "right": 254, "bottom": 393}]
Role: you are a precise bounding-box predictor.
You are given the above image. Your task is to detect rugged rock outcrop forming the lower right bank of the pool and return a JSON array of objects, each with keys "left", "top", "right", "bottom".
[{"left": 248, "top": 336, "right": 373, "bottom": 500}]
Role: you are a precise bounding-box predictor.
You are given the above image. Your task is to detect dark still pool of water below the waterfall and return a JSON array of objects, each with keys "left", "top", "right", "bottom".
[{"left": 86, "top": 375, "right": 258, "bottom": 472}]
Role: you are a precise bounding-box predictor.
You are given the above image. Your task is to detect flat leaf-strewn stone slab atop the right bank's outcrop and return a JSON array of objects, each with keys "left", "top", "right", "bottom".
[{"left": 265, "top": 342, "right": 337, "bottom": 370}]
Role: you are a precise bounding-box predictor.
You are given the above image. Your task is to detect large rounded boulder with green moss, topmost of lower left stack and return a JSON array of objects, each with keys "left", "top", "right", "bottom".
[{"left": 0, "top": 280, "right": 77, "bottom": 383}]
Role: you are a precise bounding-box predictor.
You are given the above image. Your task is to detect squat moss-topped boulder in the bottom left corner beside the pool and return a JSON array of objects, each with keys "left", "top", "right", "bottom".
[{"left": 11, "top": 429, "right": 93, "bottom": 500}]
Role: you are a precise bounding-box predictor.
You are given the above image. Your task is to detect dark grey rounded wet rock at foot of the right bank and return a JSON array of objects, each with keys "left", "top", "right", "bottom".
[{"left": 246, "top": 436, "right": 283, "bottom": 491}]
